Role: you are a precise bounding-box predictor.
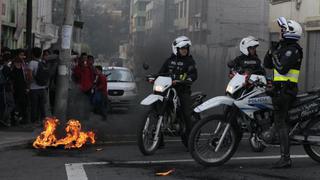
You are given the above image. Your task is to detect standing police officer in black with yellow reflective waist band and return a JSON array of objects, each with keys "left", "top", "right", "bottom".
[{"left": 264, "top": 17, "right": 303, "bottom": 168}]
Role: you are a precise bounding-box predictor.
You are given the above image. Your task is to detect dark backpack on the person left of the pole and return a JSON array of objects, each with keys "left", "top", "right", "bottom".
[{"left": 34, "top": 61, "right": 50, "bottom": 86}]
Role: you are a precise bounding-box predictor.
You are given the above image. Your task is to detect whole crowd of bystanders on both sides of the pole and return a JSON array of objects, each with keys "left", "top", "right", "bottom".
[{"left": 0, "top": 47, "right": 107, "bottom": 127}]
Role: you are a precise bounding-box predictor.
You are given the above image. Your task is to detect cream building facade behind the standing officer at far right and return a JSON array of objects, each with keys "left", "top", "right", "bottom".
[{"left": 269, "top": 0, "right": 320, "bottom": 91}]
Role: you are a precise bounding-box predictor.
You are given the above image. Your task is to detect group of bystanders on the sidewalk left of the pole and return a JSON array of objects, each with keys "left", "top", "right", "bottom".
[{"left": 0, "top": 47, "right": 59, "bottom": 126}]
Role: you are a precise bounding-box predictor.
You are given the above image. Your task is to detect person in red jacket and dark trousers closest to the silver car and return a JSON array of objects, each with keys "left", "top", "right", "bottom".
[{"left": 92, "top": 66, "right": 107, "bottom": 120}]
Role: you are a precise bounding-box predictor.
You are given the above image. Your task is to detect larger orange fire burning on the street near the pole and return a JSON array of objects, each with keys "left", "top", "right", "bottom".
[{"left": 33, "top": 118, "right": 96, "bottom": 149}]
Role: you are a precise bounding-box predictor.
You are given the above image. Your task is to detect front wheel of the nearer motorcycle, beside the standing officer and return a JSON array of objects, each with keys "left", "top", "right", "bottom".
[{"left": 189, "top": 115, "right": 240, "bottom": 166}]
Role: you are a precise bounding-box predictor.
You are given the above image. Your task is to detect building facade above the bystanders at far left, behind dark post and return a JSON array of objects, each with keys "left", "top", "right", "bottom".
[{"left": 1, "top": 0, "right": 58, "bottom": 49}]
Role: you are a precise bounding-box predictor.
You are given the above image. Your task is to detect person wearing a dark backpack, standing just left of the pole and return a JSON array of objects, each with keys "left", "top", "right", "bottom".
[{"left": 28, "top": 47, "right": 50, "bottom": 125}]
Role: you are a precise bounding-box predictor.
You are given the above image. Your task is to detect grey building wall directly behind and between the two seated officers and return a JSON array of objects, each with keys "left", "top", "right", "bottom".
[{"left": 193, "top": 0, "right": 269, "bottom": 96}]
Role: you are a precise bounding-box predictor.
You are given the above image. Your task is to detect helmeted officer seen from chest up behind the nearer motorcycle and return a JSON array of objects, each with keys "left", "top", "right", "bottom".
[{"left": 228, "top": 36, "right": 265, "bottom": 75}]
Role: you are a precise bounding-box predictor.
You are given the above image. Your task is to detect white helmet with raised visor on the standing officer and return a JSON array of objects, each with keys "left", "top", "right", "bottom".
[{"left": 277, "top": 17, "right": 302, "bottom": 40}]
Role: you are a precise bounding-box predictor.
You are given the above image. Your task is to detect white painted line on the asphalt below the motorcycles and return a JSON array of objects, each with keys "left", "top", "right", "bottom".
[{"left": 65, "top": 155, "right": 309, "bottom": 180}]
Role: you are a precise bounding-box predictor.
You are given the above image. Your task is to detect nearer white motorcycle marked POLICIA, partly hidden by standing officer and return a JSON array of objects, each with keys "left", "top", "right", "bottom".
[{"left": 189, "top": 74, "right": 320, "bottom": 166}]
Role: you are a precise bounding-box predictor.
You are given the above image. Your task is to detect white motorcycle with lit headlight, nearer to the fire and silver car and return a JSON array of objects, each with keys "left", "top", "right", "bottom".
[{"left": 137, "top": 74, "right": 205, "bottom": 155}]
